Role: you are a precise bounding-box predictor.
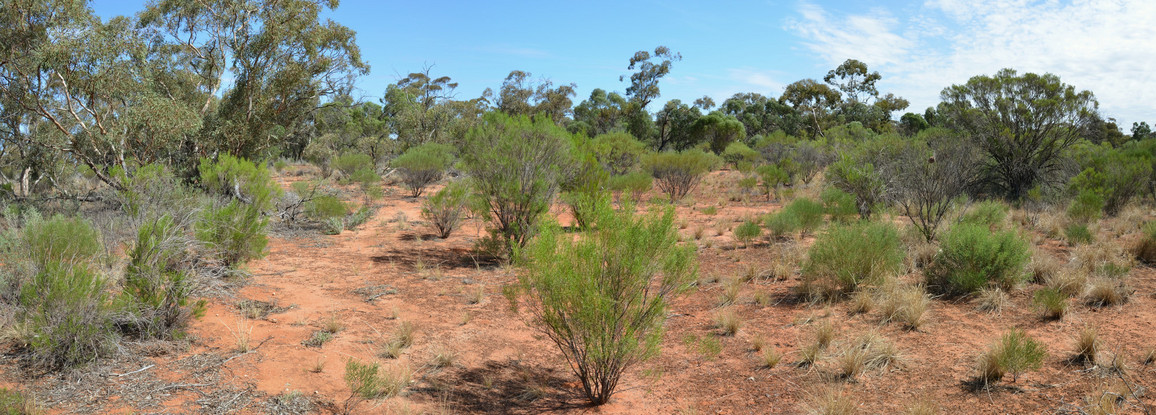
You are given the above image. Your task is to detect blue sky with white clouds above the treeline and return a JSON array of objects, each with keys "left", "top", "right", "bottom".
[{"left": 92, "top": 0, "right": 1156, "bottom": 127}]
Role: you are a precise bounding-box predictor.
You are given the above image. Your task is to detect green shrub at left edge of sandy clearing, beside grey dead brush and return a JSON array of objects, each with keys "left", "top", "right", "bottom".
[{"left": 194, "top": 200, "right": 269, "bottom": 267}]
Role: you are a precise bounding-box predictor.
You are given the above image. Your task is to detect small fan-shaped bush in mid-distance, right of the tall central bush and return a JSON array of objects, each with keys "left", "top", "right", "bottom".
[{"left": 643, "top": 149, "right": 718, "bottom": 201}]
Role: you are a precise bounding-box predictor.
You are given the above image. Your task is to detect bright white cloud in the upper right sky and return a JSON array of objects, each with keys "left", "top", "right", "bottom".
[{"left": 787, "top": 0, "right": 1156, "bottom": 126}]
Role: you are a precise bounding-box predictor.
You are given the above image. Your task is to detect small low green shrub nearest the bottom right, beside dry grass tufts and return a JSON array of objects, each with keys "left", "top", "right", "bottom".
[{"left": 979, "top": 328, "right": 1047, "bottom": 384}]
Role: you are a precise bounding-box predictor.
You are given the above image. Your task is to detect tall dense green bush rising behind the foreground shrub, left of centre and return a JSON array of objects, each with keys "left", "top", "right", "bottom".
[{"left": 462, "top": 113, "right": 573, "bottom": 252}]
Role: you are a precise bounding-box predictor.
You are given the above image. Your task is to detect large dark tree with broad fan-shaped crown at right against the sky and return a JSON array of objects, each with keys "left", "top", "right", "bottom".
[{"left": 939, "top": 69, "right": 1097, "bottom": 200}]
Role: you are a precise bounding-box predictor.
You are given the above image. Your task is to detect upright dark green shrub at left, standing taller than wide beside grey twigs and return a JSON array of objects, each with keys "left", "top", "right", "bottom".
[{"left": 117, "top": 216, "right": 205, "bottom": 339}]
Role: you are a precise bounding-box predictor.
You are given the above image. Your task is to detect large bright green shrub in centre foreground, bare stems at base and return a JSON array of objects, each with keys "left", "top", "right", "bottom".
[{"left": 518, "top": 203, "right": 696, "bottom": 405}]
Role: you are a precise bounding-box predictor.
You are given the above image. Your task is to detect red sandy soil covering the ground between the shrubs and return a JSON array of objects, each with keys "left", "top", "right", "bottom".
[{"left": 6, "top": 171, "right": 1156, "bottom": 414}]
